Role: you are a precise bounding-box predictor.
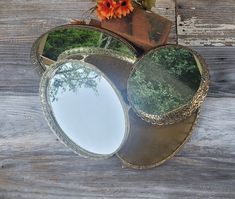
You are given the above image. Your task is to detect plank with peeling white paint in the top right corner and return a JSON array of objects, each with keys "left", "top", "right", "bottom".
[{"left": 176, "top": 0, "right": 235, "bottom": 46}]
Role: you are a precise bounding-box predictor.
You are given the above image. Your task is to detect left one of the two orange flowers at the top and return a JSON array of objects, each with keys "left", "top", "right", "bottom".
[{"left": 96, "top": 0, "right": 116, "bottom": 20}]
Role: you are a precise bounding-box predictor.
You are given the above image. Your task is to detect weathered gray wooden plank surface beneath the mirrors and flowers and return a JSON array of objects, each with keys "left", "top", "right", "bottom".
[{"left": 0, "top": 0, "right": 235, "bottom": 199}]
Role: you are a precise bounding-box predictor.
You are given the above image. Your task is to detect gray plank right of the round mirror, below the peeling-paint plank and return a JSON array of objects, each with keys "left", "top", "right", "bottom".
[{"left": 193, "top": 47, "right": 235, "bottom": 97}]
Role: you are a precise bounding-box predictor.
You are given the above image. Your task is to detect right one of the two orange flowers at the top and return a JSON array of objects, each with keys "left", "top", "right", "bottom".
[{"left": 114, "top": 0, "right": 134, "bottom": 18}]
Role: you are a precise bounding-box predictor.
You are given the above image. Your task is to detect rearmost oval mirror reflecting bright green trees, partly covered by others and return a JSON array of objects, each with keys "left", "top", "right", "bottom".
[{"left": 31, "top": 25, "right": 137, "bottom": 74}]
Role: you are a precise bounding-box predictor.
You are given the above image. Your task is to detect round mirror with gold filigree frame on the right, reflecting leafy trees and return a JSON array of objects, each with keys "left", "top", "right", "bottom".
[{"left": 127, "top": 45, "right": 209, "bottom": 125}]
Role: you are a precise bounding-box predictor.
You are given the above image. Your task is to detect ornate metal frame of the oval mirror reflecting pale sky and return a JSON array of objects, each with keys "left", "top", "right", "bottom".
[{"left": 39, "top": 60, "right": 130, "bottom": 159}]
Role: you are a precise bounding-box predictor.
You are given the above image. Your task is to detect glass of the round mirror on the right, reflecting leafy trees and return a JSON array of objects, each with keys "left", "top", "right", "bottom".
[{"left": 128, "top": 45, "right": 201, "bottom": 115}]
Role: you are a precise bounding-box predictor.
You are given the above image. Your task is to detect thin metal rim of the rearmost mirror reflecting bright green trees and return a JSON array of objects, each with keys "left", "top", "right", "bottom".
[{"left": 30, "top": 24, "right": 139, "bottom": 76}]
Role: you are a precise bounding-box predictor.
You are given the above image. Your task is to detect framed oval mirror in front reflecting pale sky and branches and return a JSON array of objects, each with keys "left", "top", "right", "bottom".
[{"left": 40, "top": 60, "right": 129, "bottom": 158}]
